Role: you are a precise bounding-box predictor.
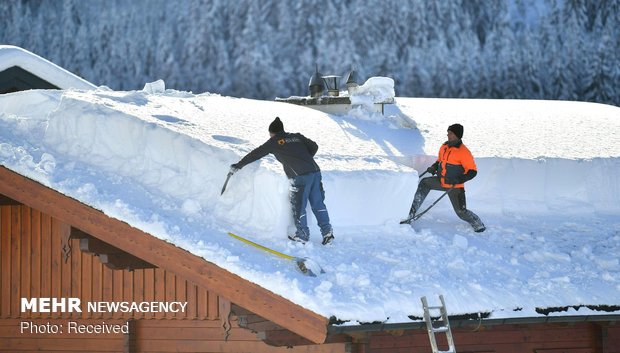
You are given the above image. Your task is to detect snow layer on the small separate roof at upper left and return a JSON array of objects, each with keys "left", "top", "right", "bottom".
[{"left": 0, "top": 45, "right": 96, "bottom": 90}]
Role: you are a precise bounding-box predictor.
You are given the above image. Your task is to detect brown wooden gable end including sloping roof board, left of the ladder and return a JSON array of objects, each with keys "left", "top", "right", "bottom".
[{"left": 0, "top": 167, "right": 349, "bottom": 352}]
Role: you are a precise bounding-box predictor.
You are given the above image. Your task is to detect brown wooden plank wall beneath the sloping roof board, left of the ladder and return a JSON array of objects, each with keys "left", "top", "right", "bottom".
[{"left": 0, "top": 205, "right": 350, "bottom": 353}]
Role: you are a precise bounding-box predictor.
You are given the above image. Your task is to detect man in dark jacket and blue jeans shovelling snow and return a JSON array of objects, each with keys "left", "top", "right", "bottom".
[{"left": 230, "top": 117, "right": 334, "bottom": 245}]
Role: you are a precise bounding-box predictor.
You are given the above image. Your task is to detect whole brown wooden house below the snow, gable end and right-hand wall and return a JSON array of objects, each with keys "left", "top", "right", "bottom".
[{"left": 0, "top": 166, "right": 620, "bottom": 353}]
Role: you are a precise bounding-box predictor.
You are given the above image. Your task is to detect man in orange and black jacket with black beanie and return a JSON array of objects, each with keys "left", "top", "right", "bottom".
[{"left": 403, "top": 124, "right": 486, "bottom": 232}]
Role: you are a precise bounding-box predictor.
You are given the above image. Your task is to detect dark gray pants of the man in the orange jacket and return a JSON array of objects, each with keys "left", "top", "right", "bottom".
[{"left": 409, "top": 177, "right": 484, "bottom": 230}]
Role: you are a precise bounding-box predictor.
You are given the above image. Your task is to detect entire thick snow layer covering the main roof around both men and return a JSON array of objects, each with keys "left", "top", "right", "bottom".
[{"left": 0, "top": 87, "right": 620, "bottom": 323}]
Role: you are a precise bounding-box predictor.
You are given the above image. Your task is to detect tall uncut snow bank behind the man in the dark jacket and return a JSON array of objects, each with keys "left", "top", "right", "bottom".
[{"left": 2, "top": 85, "right": 416, "bottom": 237}]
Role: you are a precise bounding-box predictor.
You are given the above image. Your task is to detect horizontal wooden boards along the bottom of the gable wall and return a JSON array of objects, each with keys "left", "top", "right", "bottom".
[{"left": 0, "top": 319, "right": 351, "bottom": 353}]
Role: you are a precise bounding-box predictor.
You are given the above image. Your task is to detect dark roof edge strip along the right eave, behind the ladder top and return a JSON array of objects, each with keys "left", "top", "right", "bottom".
[{"left": 328, "top": 314, "right": 620, "bottom": 334}]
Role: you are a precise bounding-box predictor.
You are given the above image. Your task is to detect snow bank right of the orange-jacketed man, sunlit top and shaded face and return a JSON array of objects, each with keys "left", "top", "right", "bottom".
[{"left": 388, "top": 98, "right": 620, "bottom": 215}]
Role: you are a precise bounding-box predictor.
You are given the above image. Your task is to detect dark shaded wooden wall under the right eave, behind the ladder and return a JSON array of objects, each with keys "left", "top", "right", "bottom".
[{"left": 359, "top": 323, "right": 608, "bottom": 353}]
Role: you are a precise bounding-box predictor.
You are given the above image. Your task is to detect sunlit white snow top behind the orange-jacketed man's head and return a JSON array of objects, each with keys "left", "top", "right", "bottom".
[{"left": 394, "top": 97, "right": 620, "bottom": 160}]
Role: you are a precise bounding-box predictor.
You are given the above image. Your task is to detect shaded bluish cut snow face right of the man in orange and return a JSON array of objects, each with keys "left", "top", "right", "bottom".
[{"left": 467, "top": 157, "right": 620, "bottom": 216}]
